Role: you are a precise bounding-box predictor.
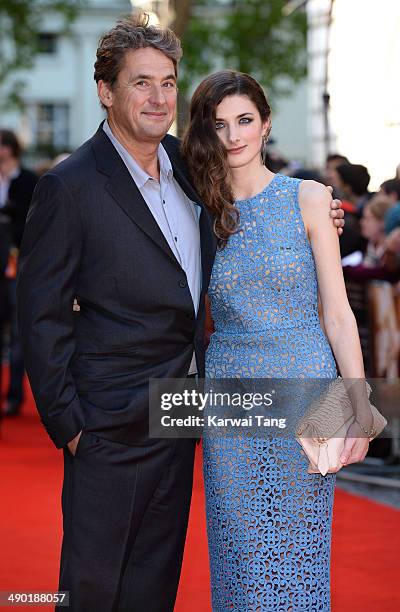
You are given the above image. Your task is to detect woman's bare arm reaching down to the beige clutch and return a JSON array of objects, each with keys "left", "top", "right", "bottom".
[{"left": 299, "top": 181, "right": 372, "bottom": 464}]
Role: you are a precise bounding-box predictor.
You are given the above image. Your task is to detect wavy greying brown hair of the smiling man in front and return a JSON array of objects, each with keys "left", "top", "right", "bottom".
[{"left": 94, "top": 13, "right": 182, "bottom": 88}]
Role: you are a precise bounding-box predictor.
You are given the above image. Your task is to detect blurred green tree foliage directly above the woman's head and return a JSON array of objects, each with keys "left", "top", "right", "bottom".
[{"left": 176, "top": 0, "right": 307, "bottom": 95}]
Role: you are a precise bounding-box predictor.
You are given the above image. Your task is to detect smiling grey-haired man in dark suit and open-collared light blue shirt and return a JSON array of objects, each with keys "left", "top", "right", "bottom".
[{"left": 18, "top": 10, "right": 346, "bottom": 612}]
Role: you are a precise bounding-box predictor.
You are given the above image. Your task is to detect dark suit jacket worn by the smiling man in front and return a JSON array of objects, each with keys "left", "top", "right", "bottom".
[{"left": 18, "top": 126, "right": 216, "bottom": 447}]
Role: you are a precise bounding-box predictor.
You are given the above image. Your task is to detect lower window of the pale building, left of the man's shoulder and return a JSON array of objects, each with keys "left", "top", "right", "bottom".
[{"left": 30, "top": 103, "right": 70, "bottom": 152}]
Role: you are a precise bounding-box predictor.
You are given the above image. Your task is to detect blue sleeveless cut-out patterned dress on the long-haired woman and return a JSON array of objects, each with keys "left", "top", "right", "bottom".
[{"left": 203, "top": 174, "right": 337, "bottom": 612}]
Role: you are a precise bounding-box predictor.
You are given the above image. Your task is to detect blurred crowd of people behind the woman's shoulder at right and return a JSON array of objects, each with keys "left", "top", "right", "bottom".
[{"left": 267, "top": 153, "right": 400, "bottom": 282}]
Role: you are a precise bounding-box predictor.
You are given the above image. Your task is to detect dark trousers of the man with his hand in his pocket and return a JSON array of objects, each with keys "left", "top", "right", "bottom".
[{"left": 59, "top": 432, "right": 195, "bottom": 612}]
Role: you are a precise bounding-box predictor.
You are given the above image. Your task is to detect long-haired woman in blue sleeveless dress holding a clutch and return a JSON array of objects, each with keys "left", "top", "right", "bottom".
[{"left": 183, "top": 71, "right": 372, "bottom": 612}]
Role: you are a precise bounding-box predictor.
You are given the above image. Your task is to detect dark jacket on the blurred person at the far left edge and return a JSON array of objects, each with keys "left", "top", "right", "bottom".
[{"left": 2, "top": 168, "right": 38, "bottom": 248}]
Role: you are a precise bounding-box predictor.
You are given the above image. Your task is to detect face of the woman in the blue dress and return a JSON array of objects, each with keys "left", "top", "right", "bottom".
[{"left": 215, "top": 95, "right": 270, "bottom": 168}]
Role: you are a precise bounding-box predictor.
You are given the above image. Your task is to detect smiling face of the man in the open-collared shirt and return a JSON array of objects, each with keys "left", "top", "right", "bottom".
[{"left": 99, "top": 47, "right": 177, "bottom": 143}]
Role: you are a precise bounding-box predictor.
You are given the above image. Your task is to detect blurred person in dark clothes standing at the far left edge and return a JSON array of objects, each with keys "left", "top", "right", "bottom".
[{"left": 0, "top": 129, "right": 38, "bottom": 416}]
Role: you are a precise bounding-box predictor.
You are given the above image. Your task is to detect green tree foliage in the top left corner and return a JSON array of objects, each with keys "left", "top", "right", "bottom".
[{"left": 0, "top": 0, "right": 85, "bottom": 107}]
